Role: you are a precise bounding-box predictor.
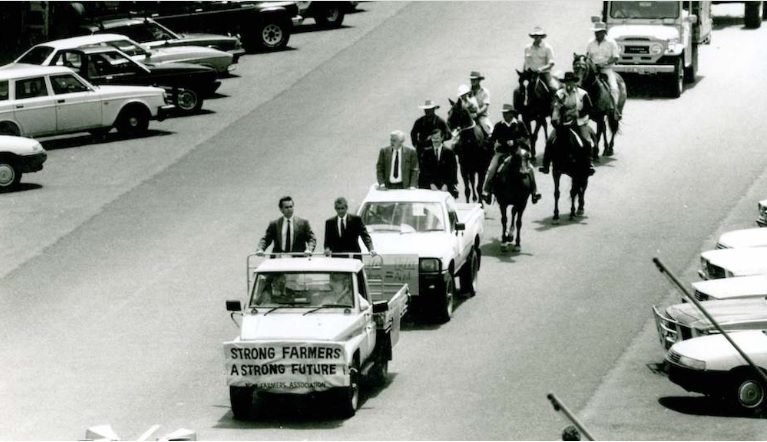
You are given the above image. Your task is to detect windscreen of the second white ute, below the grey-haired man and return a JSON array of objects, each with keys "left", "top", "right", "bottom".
[{"left": 361, "top": 201, "right": 445, "bottom": 233}]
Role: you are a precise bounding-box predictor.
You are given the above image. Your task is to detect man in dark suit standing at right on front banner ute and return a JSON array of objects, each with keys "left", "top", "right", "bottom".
[{"left": 325, "top": 197, "right": 376, "bottom": 259}]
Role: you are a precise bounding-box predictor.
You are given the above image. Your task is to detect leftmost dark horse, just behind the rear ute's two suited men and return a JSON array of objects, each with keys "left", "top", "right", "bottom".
[{"left": 447, "top": 99, "right": 493, "bottom": 203}]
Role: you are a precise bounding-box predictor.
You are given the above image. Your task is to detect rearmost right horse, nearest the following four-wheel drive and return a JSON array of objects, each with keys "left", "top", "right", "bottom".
[{"left": 573, "top": 54, "right": 626, "bottom": 161}]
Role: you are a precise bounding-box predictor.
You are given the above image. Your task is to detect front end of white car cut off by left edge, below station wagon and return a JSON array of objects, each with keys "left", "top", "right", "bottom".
[{"left": 0, "top": 135, "right": 48, "bottom": 192}]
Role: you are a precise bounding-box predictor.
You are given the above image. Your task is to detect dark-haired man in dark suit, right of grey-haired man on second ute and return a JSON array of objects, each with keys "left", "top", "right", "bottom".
[{"left": 420, "top": 129, "right": 458, "bottom": 198}]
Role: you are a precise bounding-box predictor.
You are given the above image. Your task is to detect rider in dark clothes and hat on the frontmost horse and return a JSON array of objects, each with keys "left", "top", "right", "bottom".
[{"left": 482, "top": 104, "right": 541, "bottom": 204}]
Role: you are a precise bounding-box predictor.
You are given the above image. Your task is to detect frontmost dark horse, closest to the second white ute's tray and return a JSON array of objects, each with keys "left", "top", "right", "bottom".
[{"left": 493, "top": 149, "right": 532, "bottom": 252}]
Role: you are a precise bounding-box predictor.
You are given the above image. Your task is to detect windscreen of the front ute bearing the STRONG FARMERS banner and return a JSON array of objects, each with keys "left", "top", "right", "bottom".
[{"left": 250, "top": 272, "right": 354, "bottom": 308}]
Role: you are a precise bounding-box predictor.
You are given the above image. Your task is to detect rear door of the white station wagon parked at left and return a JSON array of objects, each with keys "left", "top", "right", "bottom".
[{"left": 12, "top": 75, "right": 57, "bottom": 136}]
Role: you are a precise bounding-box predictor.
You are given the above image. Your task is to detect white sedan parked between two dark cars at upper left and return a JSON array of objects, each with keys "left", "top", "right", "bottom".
[{"left": 15, "top": 34, "right": 234, "bottom": 75}]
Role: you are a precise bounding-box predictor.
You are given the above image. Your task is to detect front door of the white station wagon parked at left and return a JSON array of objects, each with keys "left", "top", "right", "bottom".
[{"left": 50, "top": 74, "right": 104, "bottom": 132}]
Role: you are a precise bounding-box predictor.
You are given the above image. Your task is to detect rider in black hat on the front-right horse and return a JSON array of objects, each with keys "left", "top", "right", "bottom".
[{"left": 538, "top": 71, "right": 594, "bottom": 175}]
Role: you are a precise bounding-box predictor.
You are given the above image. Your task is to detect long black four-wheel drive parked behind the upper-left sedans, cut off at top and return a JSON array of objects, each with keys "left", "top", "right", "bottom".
[{"left": 114, "top": 1, "right": 300, "bottom": 52}]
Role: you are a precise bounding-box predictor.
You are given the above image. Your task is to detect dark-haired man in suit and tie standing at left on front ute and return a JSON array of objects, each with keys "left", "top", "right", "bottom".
[{"left": 256, "top": 196, "right": 317, "bottom": 256}]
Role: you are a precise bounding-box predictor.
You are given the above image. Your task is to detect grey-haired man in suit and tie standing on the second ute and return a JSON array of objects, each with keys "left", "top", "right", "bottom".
[{"left": 376, "top": 130, "right": 418, "bottom": 190}]
